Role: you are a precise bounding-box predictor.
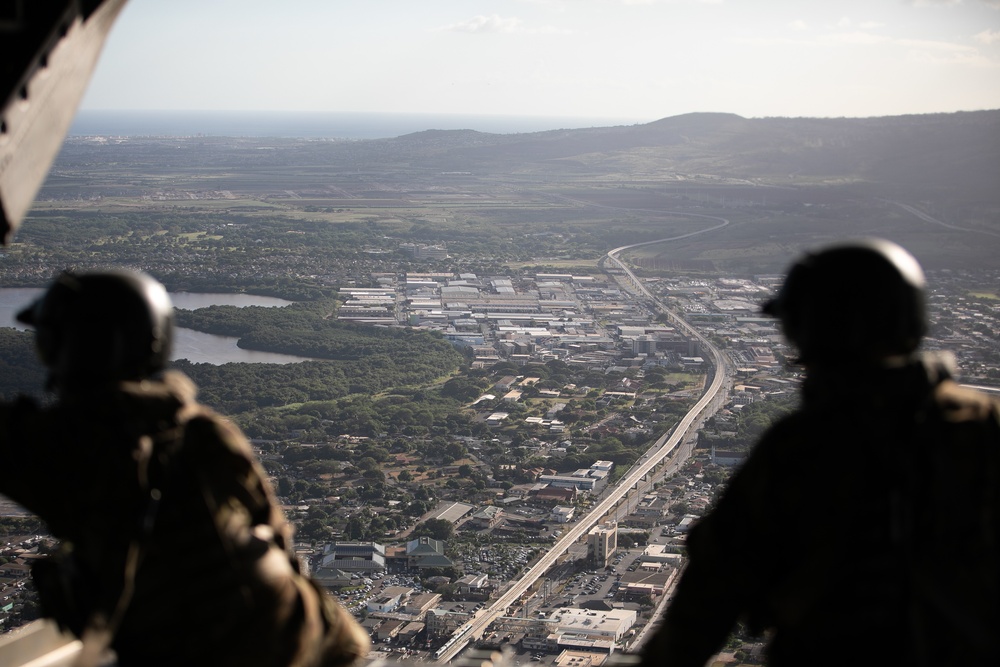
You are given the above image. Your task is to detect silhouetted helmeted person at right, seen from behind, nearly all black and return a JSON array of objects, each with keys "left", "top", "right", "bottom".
[{"left": 643, "top": 239, "right": 1000, "bottom": 667}]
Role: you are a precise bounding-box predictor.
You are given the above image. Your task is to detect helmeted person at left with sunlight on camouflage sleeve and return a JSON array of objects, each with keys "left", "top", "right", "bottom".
[{"left": 0, "top": 271, "right": 369, "bottom": 667}]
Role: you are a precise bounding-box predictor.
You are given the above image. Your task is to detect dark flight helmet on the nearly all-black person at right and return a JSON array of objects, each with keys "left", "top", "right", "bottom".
[{"left": 763, "top": 239, "right": 927, "bottom": 365}]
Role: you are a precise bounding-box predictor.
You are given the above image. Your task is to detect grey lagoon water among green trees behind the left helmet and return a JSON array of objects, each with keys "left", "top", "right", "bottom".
[{"left": 0, "top": 287, "right": 307, "bottom": 365}]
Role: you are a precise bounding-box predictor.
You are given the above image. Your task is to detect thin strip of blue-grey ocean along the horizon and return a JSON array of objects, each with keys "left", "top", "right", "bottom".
[{"left": 69, "top": 109, "right": 654, "bottom": 139}]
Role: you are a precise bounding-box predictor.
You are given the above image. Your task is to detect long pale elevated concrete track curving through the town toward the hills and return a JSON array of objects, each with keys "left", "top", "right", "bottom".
[{"left": 434, "top": 224, "right": 732, "bottom": 663}]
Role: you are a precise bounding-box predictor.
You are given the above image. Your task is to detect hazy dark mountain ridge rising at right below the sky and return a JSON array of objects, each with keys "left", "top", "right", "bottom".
[{"left": 374, "top": 110, "right": 1000, "bottom": 205}]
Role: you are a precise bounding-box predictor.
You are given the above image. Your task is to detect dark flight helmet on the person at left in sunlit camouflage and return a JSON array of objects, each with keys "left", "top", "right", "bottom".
[{"left": 17, "top": 269, "right": 174, "bottom": 388}]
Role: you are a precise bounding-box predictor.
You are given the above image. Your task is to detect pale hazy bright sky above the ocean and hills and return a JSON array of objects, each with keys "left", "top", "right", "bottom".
[{"left": 81, "top": 0, "right": 1000, "bottom": 122}]
